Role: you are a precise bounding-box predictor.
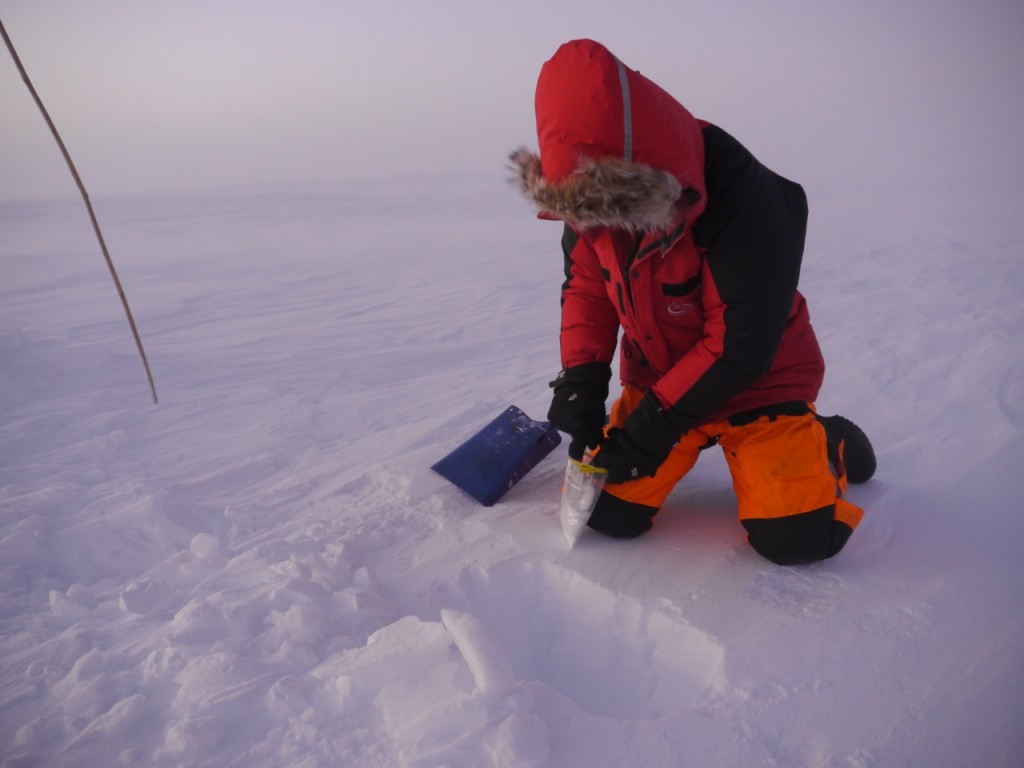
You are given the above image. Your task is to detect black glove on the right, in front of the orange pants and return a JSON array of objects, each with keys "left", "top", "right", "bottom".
[{"left": 594, "top": 391, "right": 682, "bottom": 483}]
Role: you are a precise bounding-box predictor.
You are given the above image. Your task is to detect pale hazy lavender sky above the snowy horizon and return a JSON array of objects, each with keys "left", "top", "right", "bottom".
[{"left": 0, "top": 0, "right": 1024, "bottom": 201}]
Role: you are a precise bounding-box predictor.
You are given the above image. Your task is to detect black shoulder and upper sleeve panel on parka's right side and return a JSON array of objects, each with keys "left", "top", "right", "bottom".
[{"left": 674, "top": 125, "right": 807, "bottom": 430}]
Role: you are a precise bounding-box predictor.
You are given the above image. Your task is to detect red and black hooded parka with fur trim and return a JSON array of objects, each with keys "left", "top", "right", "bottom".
[{"left": 513, "top": 40, "right": 824, "bottom": 430}]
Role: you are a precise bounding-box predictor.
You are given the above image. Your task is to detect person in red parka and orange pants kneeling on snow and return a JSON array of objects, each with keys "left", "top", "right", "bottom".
[{"left": 511, "top": 40, "right": 874, "bottom": 563}]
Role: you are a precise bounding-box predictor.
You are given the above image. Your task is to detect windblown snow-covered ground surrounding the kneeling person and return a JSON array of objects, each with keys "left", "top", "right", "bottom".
[{"left": 0, "top": 177, "right": 1024, "bottom": 768}]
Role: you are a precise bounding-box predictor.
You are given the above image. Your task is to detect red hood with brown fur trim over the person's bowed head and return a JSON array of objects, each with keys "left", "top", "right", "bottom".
[{"left": 511, "top": 40, "right": 705, "bottom": 231}]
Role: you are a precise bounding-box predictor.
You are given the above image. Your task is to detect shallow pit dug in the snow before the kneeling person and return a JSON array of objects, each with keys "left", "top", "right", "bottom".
[{"left": 445, "top": 561, "right": 726, "bottom": 720}]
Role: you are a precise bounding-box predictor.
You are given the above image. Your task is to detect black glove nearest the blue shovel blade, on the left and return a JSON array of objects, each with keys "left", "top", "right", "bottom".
[{"left": 548, "top": 362, "right": 611, "bottom": 461}]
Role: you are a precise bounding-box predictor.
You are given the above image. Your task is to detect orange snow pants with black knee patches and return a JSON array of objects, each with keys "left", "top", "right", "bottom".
[{"left": 589, "top": 385, "right": 864, "bottom": 564}]
